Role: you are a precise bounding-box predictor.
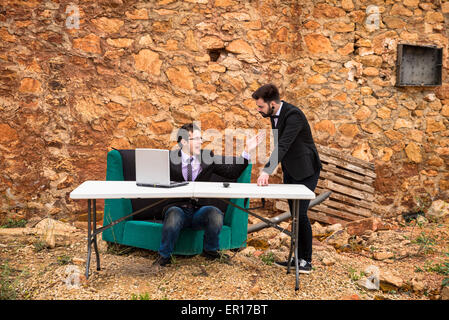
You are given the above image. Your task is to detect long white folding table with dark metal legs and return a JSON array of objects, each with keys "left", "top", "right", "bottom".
[{"left": 70, "top": 181, "right": 315, "bottom": 290}]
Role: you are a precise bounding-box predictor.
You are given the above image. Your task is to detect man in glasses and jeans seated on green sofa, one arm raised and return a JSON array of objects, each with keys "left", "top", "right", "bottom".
[{"left": 154, "top": 123, "right": 263, "bottom": 266}]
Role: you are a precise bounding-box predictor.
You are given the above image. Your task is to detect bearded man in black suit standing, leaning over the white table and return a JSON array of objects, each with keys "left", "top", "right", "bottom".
[{"left": 252, "top": 84, "right": 321, "bottom": 273}]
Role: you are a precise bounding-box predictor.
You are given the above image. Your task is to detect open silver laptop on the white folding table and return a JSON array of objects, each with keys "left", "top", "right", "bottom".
[{"left": 136, "top": 148, "right": 188, "bottom": 188}]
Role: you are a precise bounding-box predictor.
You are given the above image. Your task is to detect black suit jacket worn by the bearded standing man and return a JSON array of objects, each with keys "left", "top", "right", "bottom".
[{"left": 263, "top": 101, "right": 321, "bottom": 180}]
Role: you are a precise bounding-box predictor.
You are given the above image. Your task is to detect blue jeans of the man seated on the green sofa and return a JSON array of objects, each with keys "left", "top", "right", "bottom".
[{"left": 159, "top": 206, "right": 224, "bottom": 258}]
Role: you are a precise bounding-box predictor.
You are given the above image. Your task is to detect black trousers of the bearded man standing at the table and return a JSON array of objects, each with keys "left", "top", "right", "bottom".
[{"left": 283, "top": 170, "right": 320, "bottom": 262}]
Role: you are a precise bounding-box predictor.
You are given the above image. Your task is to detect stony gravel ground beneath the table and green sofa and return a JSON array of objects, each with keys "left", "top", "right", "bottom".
[{"left": 0, "top": 216, "right": 449, "bottom": 300}]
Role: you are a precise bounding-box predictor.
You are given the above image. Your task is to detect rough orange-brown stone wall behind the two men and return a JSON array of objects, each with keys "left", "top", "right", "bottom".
[{"left": 0, "top": 0, "right": 449, "bottom": 224}]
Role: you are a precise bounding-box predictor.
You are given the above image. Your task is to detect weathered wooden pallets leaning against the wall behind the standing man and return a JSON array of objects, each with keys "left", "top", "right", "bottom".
[{"left": 308, "top": 145, "right": 376, "bottom": 225}]
